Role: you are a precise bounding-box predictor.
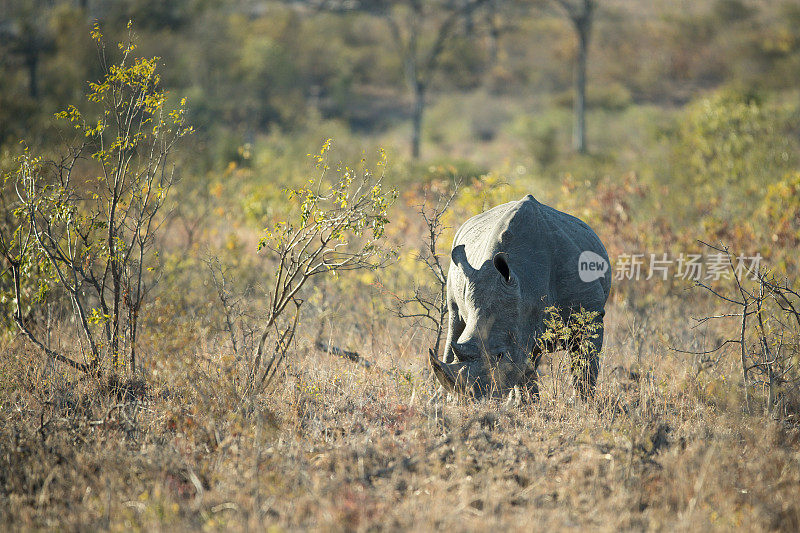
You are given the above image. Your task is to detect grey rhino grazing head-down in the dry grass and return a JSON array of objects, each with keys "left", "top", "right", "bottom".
[{"left": 430, "top": 195, "right": 611, "bottom": 396}]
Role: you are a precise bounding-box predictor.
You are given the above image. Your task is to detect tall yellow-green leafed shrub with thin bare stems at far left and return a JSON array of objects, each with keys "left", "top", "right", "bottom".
[{"left": 0, "top": 25, "right": 192, "bottom": 374}]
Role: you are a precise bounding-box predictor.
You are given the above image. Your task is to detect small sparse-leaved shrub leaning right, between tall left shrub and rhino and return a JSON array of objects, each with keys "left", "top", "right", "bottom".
[{"left": 247, "top": 139, "right": 397, "bottom": 391}]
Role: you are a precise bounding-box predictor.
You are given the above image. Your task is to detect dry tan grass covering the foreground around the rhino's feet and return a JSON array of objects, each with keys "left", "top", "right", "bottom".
[{"left": 0, "top": 298, "right": 800, "bottom": 531}]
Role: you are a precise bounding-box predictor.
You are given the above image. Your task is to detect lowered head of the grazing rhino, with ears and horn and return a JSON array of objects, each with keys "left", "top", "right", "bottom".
[{"left": 430, "top": 246, "right": 541, "bottom": 397}]
